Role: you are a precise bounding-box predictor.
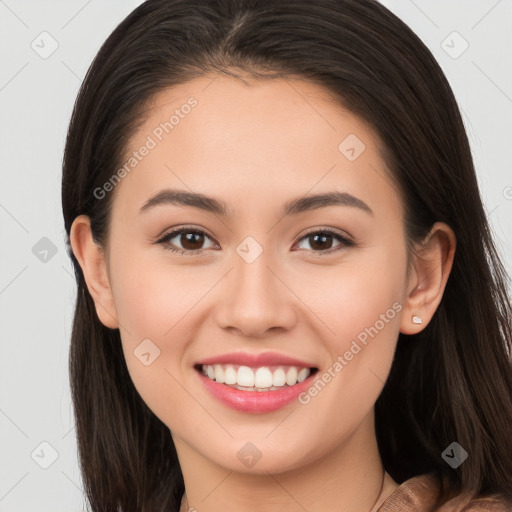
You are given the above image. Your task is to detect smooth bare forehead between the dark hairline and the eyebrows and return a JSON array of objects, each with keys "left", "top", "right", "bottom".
[{"left": 116, "top": 75, "right": 404, "bottom": 222}]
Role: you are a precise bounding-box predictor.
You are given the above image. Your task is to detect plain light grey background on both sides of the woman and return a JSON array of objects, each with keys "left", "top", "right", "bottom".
[{"left": 0, "top": 0, "right": 512, "bottom": 512}]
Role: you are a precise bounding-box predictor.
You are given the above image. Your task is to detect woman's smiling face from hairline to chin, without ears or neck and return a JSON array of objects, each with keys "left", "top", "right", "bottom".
[{"left": 97, "top": 75, "right": 408, "bottom": 473}]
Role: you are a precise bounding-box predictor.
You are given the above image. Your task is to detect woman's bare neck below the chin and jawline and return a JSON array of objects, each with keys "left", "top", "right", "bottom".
[{"left": 173, "top": 415, "right": 398, "bottom": 512}]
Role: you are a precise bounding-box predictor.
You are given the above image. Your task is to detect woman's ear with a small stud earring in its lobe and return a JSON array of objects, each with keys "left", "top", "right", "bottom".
[{"left": 400, "top": 222, "right": 457, "bottom": 334}]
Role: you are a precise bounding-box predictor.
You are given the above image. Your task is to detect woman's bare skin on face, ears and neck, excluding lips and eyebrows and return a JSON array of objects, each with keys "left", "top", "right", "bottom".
[{"left": 71, "top": 75, "right": 456, "bottom": 512}]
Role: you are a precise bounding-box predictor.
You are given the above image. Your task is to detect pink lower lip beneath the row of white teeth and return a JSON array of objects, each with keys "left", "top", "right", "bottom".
[{"left": 195, "top": 370, "right": 316, "bottom": 413}]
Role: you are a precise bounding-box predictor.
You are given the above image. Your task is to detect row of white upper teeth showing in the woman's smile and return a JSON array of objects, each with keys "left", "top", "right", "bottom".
[{"left": 201, "top": 364, "right": 311, "bottom": 391}]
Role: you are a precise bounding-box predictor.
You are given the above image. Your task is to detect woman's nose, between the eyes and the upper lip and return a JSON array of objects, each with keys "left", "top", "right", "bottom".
[{"left": 216, "top": 251, "right": 299, "bottom": 338}]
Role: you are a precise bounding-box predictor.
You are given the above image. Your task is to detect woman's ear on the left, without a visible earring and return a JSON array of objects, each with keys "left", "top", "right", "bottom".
[{"left": 69, "top": 215, "right": 119, "bottom": 329}]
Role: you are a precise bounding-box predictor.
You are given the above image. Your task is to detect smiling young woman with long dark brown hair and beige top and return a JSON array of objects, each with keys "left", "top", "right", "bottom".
[{"left": 62, "top": 0, "right": 512, "bottom": 512}]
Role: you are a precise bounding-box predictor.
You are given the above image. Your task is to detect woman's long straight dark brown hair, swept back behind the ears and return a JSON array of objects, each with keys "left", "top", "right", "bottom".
[{"left": 62, "top": 0, "right": 512, "bottom": 512}]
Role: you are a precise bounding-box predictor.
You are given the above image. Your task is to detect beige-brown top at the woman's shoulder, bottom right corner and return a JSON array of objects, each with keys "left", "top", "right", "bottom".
[{"left": 377, "top": 473, "right": 512, "bottom": 512}]
